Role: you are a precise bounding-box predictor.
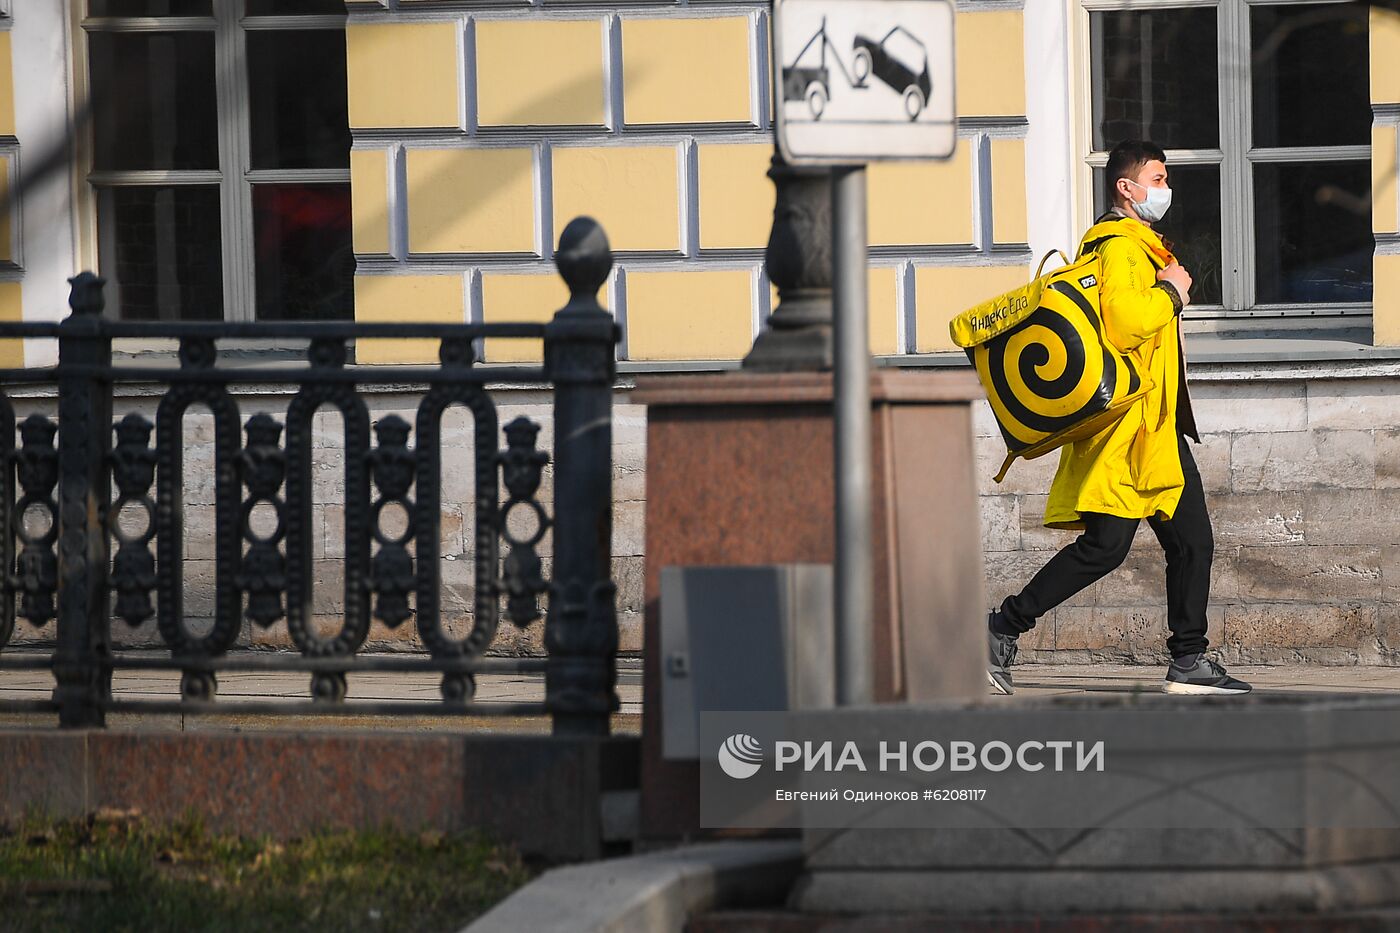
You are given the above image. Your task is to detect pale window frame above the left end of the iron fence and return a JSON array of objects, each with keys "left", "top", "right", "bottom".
[{"left": 75, "top": 0, "right": 350, "bottom": 321}]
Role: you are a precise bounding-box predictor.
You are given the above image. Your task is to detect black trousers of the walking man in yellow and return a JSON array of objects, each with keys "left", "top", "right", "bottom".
[{"left": 1001, "top": 437, "right": 1215, "bottom": 658}]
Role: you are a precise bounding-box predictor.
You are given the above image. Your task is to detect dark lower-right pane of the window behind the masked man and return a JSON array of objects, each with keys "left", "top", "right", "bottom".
[{"left": 1254, "top": 161, "right": 1375, "bottom": 304}]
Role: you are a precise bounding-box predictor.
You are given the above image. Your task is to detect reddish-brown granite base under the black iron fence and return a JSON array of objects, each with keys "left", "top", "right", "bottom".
[{"left": 0, "top": 730, "right": 638, "bottom": 860}]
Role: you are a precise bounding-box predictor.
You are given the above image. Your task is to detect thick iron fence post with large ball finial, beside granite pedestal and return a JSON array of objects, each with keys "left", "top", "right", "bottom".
[{"left": 545, "top": 217, "right": 619, "bottom": 735}]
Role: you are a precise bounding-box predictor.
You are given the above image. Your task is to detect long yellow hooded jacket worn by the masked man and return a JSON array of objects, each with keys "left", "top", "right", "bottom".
[{"left": 1044, "top": 214, "right": 1198, "bottom": 530}]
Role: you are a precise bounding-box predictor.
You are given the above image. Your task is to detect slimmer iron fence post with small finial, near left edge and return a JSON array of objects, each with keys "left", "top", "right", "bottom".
[{"left": 53, "top": 272, "right": 112, "bottom": 728}]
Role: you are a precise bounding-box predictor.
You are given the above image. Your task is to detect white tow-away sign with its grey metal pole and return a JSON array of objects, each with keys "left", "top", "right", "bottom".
[{"left": 772, "top": 0, "right": 958, "bottom": 706}]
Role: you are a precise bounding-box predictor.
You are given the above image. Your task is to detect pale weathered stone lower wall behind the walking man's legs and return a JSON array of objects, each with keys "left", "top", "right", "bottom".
[{"left": 976, "top": 363, "right": 1400, "bottom": 664}]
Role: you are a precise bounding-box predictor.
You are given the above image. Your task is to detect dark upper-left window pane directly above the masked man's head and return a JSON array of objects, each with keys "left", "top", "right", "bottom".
[{"left": 1089, "top": 7, "right": 1219, "bottom": 151}]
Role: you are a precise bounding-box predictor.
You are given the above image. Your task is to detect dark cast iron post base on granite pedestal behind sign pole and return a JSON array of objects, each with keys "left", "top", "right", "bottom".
[{"left": 743, "top": 151, "right": 832, "bottom": 373}]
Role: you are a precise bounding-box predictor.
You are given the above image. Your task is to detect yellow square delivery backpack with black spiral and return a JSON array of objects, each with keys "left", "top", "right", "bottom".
[{"left": 948, "top": 243, "right": 1152, "bottom": 483}]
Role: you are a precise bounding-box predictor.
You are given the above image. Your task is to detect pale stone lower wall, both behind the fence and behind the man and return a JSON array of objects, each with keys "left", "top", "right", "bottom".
[{"left": 15, "top": 363, "right": 1400, "bottom": 664}]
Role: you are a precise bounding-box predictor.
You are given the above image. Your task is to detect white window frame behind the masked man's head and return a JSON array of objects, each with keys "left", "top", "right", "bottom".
[{"left": 1071, "top": 0, "right": 1372, "bottom": 319}]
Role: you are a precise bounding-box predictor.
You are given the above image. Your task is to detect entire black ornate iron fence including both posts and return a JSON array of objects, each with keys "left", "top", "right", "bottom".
[{"left": 0, "top": 219, "right": 617, "bottom": 734}]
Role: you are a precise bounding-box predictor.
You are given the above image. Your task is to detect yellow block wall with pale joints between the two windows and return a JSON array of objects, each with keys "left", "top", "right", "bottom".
[{"left": 347, "top": 8, "right": 1029, "bottom": 363}]
